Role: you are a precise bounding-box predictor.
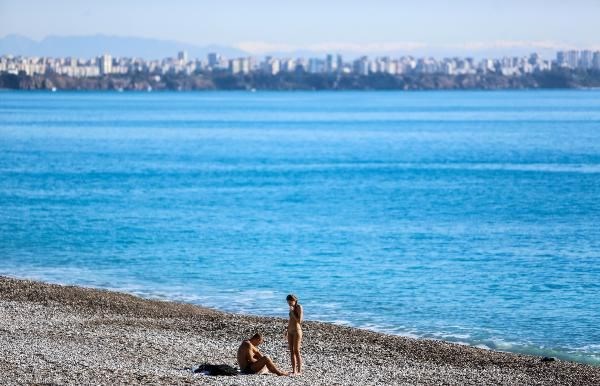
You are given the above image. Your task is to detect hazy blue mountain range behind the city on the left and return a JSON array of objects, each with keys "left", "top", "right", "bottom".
[{"left": 0, "top": 35, "right": 248, "bottom": 59}]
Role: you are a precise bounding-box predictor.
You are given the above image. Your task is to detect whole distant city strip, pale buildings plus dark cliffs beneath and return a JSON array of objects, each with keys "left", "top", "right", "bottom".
[{"left": 0, "top": 46, "right": 600, "bottom": 91}]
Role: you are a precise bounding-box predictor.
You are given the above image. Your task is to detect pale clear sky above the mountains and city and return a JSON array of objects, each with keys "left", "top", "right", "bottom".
[{"left": 0, "top": 0, "right": 600, "bottom": 55}]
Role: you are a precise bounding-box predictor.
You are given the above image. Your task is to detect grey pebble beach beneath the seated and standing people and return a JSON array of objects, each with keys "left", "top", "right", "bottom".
[{"left": 0, "top": 277, "right": 600, "bottom": 385}]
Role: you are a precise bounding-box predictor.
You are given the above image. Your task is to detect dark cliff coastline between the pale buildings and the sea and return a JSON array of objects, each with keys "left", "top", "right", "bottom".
[{"left": 0, "top": 68, "right": 600, "bottom": 91}]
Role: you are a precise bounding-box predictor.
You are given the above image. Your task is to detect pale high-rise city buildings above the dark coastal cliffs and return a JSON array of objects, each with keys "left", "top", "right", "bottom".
[{"left": 0, "top": 50, "right": 600, "bottom": 78}]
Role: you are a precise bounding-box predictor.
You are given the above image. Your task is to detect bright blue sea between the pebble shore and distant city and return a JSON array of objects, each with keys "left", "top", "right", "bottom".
[{"left": 0, "top": 91, "right": 600, "bottom": 364}]
